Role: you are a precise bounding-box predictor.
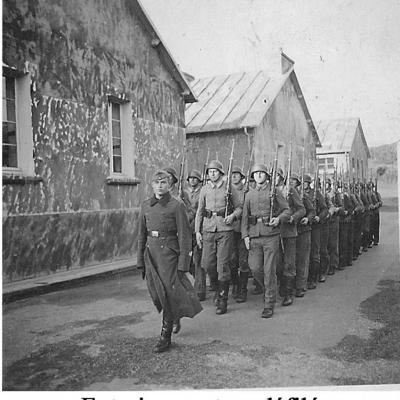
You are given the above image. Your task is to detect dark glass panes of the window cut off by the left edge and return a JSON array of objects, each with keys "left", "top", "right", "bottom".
[{"left": 3, "top": 76, "right": 18, "bottom": 168}]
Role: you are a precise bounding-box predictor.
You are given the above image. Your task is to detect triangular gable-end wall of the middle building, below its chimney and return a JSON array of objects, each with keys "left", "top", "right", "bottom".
[{"left": 255, "top": 79, "right": 315, "bottom": 172}]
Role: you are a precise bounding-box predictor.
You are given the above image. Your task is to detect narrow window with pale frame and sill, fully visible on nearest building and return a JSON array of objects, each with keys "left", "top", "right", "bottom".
[{"left": 107, "top": 96, "right": 138, "bottom": 184}]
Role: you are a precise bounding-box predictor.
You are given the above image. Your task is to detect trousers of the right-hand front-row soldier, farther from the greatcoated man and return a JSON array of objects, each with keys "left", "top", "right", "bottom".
[{"left": 249, "top": 235, "right": 279, "bottom": 308}]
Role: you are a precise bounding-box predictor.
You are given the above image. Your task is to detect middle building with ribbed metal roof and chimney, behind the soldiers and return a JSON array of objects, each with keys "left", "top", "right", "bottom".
[{"left": 186, "top": 53, "right": 320, "bottom": 177}]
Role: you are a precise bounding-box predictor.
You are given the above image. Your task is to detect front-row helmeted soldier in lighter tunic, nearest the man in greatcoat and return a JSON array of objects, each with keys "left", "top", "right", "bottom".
[{"left": 195, "top": 160, "right": 242, "bottom": 315}]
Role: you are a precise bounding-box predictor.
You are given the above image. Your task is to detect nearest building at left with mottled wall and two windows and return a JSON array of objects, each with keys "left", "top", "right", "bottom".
[{"left": 3, "top": 0, "right": 195, "bottom": 283}]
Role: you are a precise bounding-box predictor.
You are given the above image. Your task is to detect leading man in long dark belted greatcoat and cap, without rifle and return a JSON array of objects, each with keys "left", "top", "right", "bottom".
[{"left": 137, "top": 170, "right": 202, "bottom": 353}]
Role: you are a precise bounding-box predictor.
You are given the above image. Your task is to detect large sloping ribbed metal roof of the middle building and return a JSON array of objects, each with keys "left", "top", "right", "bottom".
[{"left": 185, "top": 70, "right": 292, "bottom": 133}]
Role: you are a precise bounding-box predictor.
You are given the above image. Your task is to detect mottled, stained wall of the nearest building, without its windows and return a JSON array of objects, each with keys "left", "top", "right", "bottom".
[{"left": 3, "top": 0, "right": 185, "bottom": 280}]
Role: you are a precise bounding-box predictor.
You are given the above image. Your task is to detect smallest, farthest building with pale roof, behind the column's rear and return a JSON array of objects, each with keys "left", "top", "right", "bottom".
[{"left": 316, "top": 117, "right": 371, "bottom": 180}]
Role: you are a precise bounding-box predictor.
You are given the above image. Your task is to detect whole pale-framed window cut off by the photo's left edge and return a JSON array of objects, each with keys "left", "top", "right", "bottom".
[{"left": 2, "top": 66, "right": 34, "bottom": 177}]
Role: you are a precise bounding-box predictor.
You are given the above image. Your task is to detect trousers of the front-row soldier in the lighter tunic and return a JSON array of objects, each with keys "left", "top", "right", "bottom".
[{"left": 201, "top": 231, "right": 233, "bottom": 282}]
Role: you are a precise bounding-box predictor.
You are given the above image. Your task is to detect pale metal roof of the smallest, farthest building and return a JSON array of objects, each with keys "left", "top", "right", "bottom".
[{"left": 316, "top": 118, "right": 360, "bottom": 153}]
